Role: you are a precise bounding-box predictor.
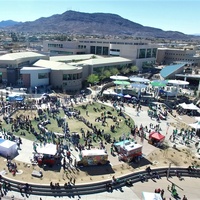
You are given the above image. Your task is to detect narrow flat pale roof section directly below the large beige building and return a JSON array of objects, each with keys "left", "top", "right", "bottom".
[{"left": 50, "top": 54, "right": 102, "bottom": 62}]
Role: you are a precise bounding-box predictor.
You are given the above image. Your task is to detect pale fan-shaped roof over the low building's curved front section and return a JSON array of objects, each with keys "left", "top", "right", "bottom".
[{"left": 33, "top": 60, "right": 81, "bottom": 70}]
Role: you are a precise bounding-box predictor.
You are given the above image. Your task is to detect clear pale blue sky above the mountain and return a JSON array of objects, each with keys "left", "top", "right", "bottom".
[{"left": 0, "top": 0, "right": 200, "bottom": 34}]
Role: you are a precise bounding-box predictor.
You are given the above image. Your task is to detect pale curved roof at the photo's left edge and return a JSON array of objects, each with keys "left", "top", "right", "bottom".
[{"left": 0, "top": 52, "right": 46, "bottom": 60}]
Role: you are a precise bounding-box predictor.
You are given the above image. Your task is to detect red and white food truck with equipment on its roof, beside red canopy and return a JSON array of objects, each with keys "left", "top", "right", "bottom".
[{"left": 114, "top": 140, "right": 142, "bottom": 162}]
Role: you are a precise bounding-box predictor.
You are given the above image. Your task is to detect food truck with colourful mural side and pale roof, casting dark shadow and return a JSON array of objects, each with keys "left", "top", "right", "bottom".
[{"left": 78, "top": 149, "right": 108, "bottom": 166}]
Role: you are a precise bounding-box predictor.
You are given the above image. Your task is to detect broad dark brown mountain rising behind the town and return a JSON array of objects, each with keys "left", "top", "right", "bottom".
[{"left": 0, "top": 11, "right": 197, "bottom": 40}]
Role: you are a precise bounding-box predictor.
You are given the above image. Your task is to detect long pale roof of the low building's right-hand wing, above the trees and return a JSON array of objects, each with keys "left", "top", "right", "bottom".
[{"left": 70, "top": 57, "right": 132, "bottom": 65}]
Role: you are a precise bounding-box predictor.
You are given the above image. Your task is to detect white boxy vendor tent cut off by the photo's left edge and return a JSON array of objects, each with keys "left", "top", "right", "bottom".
[{"left": 0, "top": 139, "right": 17, "bottom": 158}]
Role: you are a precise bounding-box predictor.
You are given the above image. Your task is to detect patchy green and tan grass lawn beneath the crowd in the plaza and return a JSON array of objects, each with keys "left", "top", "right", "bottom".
[{"left": 2, "top": 103, "right": 134, "bottom": 145}]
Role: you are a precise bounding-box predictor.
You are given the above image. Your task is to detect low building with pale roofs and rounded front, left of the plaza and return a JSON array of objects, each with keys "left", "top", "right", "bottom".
[{"left": 0, "top": 52, "right": 132, "bottom": 91}]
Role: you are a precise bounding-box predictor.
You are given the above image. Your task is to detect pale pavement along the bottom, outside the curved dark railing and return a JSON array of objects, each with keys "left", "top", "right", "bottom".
[{"left": 2, "top": 177, "right": 200, "bottom": 200}]
